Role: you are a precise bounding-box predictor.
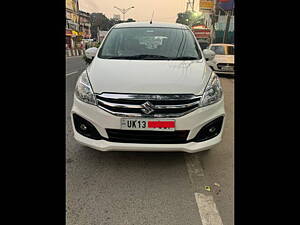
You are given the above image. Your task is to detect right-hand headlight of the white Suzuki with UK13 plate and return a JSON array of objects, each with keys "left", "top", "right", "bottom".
[{"left": 200, "top": 72, "right": 223, "bottom": 107}]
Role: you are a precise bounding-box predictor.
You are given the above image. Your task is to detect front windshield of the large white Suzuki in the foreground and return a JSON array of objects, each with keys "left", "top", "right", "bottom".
[{"left": 98, "top": 27, "right": 202, "bottom": 60}]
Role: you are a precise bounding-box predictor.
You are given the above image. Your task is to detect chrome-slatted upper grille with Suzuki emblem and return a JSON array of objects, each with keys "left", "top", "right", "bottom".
[{"left": 96, "top": 93, "right": 201, "bottom": 118}]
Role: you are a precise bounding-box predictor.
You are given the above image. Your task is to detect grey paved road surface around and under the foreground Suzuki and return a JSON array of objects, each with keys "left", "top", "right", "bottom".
[{"left": 66, "top": 57, "right": 234, "bottom": 225}]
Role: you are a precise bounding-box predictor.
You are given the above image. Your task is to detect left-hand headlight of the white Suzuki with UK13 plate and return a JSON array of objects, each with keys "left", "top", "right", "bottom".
[{"left": 75, "top": 70, "right": 96, "bottom": 105}]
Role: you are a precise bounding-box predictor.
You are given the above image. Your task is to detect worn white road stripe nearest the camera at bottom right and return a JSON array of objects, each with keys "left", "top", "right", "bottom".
[{"left": 195, "top": 193, "right": 223, "bottom": 225}]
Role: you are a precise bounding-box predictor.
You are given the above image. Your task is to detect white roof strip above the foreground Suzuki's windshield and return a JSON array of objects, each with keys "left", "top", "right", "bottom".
[{"left": 113, "top": 21, "right": 188, "bottom": 29}]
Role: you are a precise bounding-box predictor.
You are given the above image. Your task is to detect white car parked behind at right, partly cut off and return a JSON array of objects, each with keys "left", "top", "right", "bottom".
[{"left": 207, "top": 44, "right": 234, "bottom": 74}]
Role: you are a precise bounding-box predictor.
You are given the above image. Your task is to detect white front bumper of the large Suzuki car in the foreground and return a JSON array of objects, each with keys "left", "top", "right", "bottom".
[{"left": 71, "top": 96, "right": 225, "bottom": 153}]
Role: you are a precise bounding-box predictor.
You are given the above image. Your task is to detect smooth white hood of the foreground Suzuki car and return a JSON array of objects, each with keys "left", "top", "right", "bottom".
[{"left": 87, "top": 58, "right": 211, "bottom": 95}]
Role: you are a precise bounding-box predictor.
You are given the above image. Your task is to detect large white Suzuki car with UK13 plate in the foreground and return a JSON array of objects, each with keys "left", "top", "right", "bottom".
[{"left": 71, "top": 22, "right": 225, "bottom": 153}]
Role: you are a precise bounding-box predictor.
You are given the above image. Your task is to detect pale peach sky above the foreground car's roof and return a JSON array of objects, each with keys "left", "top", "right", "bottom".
[{"left": 79, "top": 0, "right": 199, "bottom": 23}]
